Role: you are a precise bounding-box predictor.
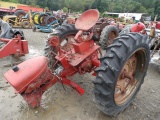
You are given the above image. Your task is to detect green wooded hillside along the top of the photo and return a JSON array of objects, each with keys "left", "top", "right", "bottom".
[{"left": 2, "top": 0, "right": 160, "bottom": 18}]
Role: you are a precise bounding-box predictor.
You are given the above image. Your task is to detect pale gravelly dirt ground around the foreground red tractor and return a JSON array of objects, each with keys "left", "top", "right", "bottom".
[{"left": 0, "top": 30, "right": 160, "bottom": 120}]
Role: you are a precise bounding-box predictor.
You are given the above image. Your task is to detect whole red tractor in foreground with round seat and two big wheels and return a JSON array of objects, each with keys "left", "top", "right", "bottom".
[{"left": 4, "top": 9, "right": 150, "bottom": 116}]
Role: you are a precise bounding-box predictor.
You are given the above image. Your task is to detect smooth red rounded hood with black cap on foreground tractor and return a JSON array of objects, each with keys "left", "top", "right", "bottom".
[{"left": 4, "top": 56, "right": 48, "bottom": 93}]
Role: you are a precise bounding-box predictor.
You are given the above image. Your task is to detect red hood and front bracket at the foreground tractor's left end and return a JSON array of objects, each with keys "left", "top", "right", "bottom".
[{"left": 4, "top": 56, "right": 57, "bottom": 108}]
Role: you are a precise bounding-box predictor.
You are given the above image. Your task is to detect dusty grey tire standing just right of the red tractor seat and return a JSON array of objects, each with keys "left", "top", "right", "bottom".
[{"left": 100, "top": 25, "right": 119, "bottom": 47}]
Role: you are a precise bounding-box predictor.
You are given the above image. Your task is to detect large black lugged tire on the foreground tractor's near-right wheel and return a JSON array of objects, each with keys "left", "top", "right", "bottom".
[{"left": 93, "top": 33, "right": 150, "bottom": 116}]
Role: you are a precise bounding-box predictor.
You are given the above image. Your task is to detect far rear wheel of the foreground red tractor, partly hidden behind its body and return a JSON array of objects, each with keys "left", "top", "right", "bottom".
[{"left": 44, "top": 24, "right": 78, "bottom": 72}]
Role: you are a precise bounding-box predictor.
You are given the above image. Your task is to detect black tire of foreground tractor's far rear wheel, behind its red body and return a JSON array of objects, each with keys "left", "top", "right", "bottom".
[{"left": 44, "top": 24, "right": 78, "bottom": 72}]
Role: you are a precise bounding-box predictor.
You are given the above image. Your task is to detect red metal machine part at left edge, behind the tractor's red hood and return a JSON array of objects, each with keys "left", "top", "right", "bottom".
[{"left": 0, "top": 30, "right": 28, "bottom": 66}]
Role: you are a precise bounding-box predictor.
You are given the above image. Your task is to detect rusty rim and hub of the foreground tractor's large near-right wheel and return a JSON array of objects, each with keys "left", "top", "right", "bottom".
[{"left": 114, "top": 50, "right": 145, "bottom": 105}]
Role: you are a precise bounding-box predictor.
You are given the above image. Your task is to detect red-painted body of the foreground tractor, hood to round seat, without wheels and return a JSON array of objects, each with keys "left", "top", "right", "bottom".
[{"left": 4, "top": 10, "right": 100, "bottom": 108}]
